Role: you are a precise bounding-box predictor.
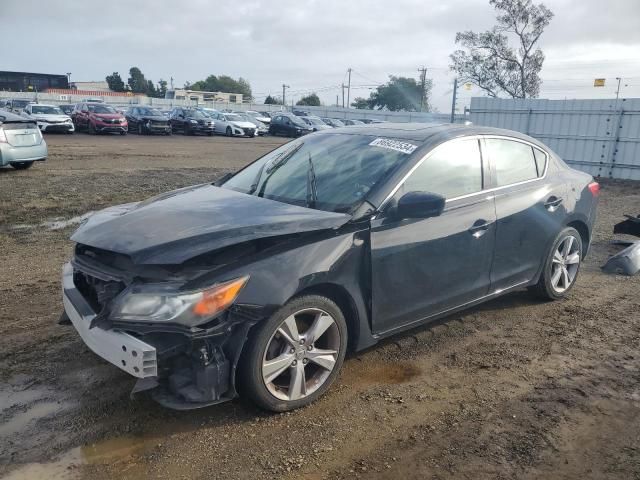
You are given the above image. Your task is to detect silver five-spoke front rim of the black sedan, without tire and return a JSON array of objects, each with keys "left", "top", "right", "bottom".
[{"left": 262, "top": 308, "right": 340, "bottom": 401}]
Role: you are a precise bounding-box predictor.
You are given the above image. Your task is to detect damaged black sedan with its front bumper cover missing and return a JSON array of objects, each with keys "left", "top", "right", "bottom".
[{"left": 63, "top": 124, "right": 599, "bottom": 411}]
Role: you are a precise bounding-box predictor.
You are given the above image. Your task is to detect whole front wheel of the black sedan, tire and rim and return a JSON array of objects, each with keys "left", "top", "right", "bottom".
[{"left": 238, "top": 295, "right": 347, "bottom": 412}]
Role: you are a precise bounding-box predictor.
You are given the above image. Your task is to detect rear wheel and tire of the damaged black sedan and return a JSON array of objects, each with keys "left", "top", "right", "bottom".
[{"left": 531, "top": 227, "right": 582, "bottom": 300}]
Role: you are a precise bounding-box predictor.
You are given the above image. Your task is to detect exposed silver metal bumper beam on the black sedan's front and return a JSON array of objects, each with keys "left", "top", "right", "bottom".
[{"left": 62, "top": 263, "right": 158, "bottom": 378}]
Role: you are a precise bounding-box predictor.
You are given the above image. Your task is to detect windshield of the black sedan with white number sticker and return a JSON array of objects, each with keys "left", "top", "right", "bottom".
[{"left": 223, "top": 134, "right": 416, "bottom": 212}]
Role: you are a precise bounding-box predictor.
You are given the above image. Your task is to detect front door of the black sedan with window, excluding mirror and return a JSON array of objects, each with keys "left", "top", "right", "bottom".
[{"left": 371, "top": 138, "right": 496, "bottom": 333}]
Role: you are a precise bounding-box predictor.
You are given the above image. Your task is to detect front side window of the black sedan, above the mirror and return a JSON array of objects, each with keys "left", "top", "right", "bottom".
[{"left": 401, "top": 139, "right": 482, "bottom": 198}]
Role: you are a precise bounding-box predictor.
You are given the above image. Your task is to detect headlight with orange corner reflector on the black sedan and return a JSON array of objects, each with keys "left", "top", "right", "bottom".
[{"left": 111, "top": 276, "right": 249, "bottom": 327}]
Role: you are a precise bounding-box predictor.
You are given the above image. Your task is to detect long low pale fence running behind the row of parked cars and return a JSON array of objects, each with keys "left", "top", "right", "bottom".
[{"left": 0, "top": 92, "right": 465, "bottom": 123}]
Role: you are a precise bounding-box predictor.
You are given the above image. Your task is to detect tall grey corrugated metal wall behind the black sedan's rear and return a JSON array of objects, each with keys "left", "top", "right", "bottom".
[{"left": 470, "top": 98, "right": 640, "bottom": 180}]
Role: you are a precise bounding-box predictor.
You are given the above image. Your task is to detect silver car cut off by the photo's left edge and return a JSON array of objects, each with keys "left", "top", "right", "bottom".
[{"left": 0, "top": 110, "right": 47, "bottom": 170}]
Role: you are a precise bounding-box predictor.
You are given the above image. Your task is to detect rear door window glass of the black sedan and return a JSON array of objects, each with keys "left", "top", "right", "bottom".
[{"left": 486, "top": 138, "right": 538, "bottom": 187}]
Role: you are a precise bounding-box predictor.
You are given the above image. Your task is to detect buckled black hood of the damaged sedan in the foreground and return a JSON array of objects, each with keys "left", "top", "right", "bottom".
[{"left": 71, "top": 184, "right": 351, "bottom": 265}]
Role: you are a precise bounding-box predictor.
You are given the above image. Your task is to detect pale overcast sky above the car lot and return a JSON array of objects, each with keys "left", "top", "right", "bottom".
[{"left": 0, "top": 0, "right": 640, "bottom": 111}]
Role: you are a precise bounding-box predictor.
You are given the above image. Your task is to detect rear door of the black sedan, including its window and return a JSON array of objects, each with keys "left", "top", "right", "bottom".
[{"left": 483, "top": 137, "right": 566, "bottom": 291}]
